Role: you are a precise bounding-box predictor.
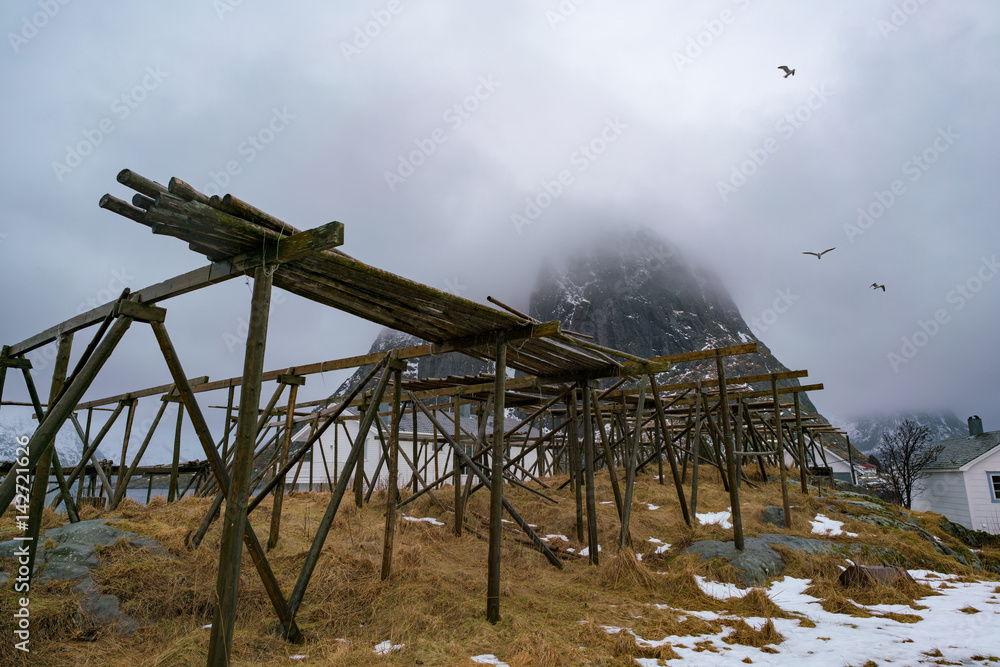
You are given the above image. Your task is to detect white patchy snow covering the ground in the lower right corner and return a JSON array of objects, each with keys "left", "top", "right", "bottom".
[{"left": 604, "top": 570, "right": 1000, "bottom": 667}]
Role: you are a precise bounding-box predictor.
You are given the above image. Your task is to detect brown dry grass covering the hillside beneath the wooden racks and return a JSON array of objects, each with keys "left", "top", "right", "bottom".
[{"left": 0, "top": 468, "right": 1000, "bottom": 667}]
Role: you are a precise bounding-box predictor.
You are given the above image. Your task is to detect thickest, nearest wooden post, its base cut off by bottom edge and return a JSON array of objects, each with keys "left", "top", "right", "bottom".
[{"left": 208, "top": 266, "right": 272, "bottom": 667}]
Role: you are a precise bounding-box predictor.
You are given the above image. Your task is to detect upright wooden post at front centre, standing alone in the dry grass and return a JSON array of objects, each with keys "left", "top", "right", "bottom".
[{"left": 486, "top": 331, "right": 507, "bottom": 624}]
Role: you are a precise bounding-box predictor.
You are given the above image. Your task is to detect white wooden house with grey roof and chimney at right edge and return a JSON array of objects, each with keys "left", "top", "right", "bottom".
[{"left": 913, "top": 417, "right": 1000, "bottom": 534}]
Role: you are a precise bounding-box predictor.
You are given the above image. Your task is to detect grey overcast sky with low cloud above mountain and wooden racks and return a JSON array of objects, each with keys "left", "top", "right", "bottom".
[{"left": 0, "top": 0, "right": 1000, "bottom": 458}]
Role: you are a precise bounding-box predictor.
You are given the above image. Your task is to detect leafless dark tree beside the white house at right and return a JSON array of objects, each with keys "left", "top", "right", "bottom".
[{"left": 875, "top": 419, "right": 944, "bottom": 509}]
